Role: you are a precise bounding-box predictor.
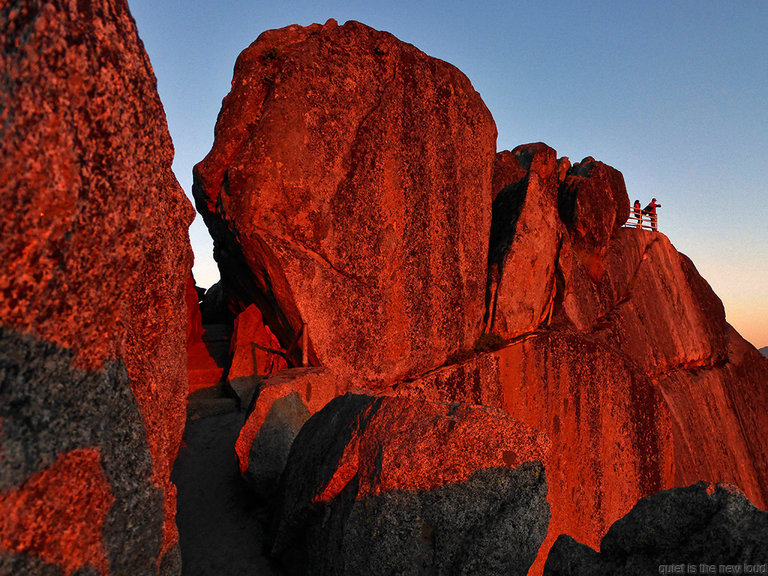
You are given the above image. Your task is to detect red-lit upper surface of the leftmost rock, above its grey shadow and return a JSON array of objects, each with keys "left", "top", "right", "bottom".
[{"left": 0, "top": 0, "right": 193, "bottom": 573}]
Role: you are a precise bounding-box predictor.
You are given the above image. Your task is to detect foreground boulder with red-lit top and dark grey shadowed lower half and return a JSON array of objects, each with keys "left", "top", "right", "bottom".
[{"left": 273, "top": 394, "right": 549, "bottom": 575}]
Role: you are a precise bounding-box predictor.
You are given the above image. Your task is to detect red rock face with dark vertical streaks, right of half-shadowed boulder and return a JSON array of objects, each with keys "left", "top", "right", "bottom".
[{"left": 494, "top": 333, "right": 673, "bottom": 573}]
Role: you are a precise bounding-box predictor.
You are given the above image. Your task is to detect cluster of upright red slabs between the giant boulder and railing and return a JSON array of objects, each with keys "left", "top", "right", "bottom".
[{"left": 486, "top": 142, "right": 629, "bottom": 339}]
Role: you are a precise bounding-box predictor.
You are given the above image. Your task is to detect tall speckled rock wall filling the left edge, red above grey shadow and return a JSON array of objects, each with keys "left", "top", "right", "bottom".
[{"left": 0, "top": 0, "right": 193, "bottom": 576}]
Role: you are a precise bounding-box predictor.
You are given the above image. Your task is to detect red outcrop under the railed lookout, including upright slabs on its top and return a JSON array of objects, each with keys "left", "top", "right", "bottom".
[{"left": 395, "top": 144, "right": 768, "bottom": 574}]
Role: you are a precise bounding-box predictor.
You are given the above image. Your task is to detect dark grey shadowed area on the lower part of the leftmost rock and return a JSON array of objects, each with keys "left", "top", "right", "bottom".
[{"left": 0, "top": 326, "right": 163, "bottom": 576}]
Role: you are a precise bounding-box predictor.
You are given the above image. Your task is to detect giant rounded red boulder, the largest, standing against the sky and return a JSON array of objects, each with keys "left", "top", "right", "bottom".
[{"left": 195, "top": 21, "right": 496, "bottom": 383}]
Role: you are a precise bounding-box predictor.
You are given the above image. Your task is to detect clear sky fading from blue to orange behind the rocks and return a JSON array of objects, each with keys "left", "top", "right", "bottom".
[{"left": 128, "top": 0, "right": 768, "bottom": 347}]
